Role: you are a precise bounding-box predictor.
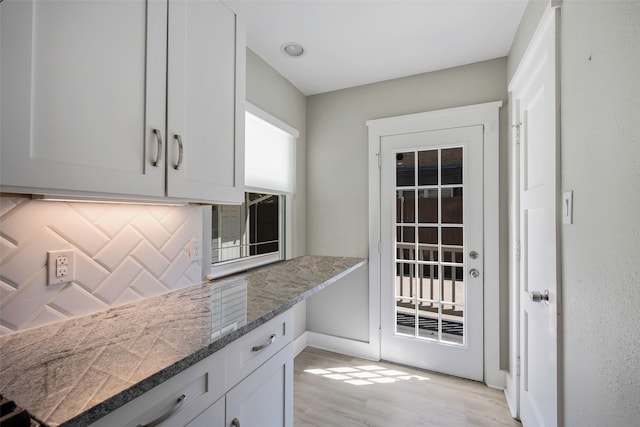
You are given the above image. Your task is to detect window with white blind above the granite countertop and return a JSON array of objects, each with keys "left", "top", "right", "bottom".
[{"left": 211, "top": 104, "right": 298, "bottom": 277}]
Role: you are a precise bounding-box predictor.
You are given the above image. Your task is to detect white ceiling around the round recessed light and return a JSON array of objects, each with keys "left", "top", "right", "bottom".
[{"left": 241, "top": 0, "right": 527, "bottom": 95}]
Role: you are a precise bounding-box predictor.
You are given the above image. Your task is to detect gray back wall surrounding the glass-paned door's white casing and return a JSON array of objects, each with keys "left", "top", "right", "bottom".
[{"left": 307, "top": 58, "right": 508, "bottom": 341}]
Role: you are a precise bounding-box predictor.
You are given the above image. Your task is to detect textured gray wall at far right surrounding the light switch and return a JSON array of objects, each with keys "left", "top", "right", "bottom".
[{"left": 510, "top": 0, "right": 640, "bottom": 426}]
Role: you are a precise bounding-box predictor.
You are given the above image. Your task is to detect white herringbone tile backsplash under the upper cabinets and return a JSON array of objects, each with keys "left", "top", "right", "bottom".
[{"left": 0, "top": 197, "right": 204, "bottom": 335}]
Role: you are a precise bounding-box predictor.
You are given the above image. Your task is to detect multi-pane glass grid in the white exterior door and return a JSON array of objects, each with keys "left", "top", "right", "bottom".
[{"left": 396, "top": 147, "right": 466, "bottom": 345}]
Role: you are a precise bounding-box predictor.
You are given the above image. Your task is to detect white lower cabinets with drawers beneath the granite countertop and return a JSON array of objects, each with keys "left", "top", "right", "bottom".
[{"left": 91, "top": 312, "right": 293, "bottom": 427}]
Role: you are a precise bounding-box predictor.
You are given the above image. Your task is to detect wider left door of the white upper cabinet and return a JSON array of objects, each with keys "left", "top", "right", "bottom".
[{"left": 0, "top": 0, "right": 167, "bottom": 197}]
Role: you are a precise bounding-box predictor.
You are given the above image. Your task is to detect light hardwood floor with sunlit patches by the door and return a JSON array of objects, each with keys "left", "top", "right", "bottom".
[{"left": 293, "top": 347, "right": 521, "bottom": 427}]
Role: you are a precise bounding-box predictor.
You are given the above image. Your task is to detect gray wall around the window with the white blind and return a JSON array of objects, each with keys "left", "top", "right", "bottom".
[{"left": 247, "top": 49, "right": 307, "bottom": 337}]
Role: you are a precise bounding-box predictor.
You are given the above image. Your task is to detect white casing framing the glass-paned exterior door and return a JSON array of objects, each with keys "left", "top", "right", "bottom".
[{"left": 366, "top": 101, "right": 505, "bottom": 389}]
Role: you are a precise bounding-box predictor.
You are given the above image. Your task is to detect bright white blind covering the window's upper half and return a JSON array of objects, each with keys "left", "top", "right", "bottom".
[{"left": 245, "top": 112, "right": 296, "bottom": 193}]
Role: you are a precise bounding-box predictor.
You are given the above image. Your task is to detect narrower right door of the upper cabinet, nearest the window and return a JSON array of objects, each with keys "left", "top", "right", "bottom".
[{"left": 167, "top": 0, "right": 245, "bottom": 203}]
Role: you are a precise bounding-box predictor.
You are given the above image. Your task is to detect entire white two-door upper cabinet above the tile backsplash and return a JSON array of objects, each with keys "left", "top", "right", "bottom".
[{"left": 0, "top": 0, "right": 245, "bottom": 202}]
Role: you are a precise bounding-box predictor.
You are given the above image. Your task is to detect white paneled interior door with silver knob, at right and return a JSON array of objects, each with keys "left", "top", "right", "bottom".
[{"left": 510, "top": 6, "right": 560, "bottom": 427}]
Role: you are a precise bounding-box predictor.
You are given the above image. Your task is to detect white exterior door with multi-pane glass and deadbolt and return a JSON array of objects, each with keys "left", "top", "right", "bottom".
[{"left": 380, "top": 125, "right": 484, "bottom": 381}]
